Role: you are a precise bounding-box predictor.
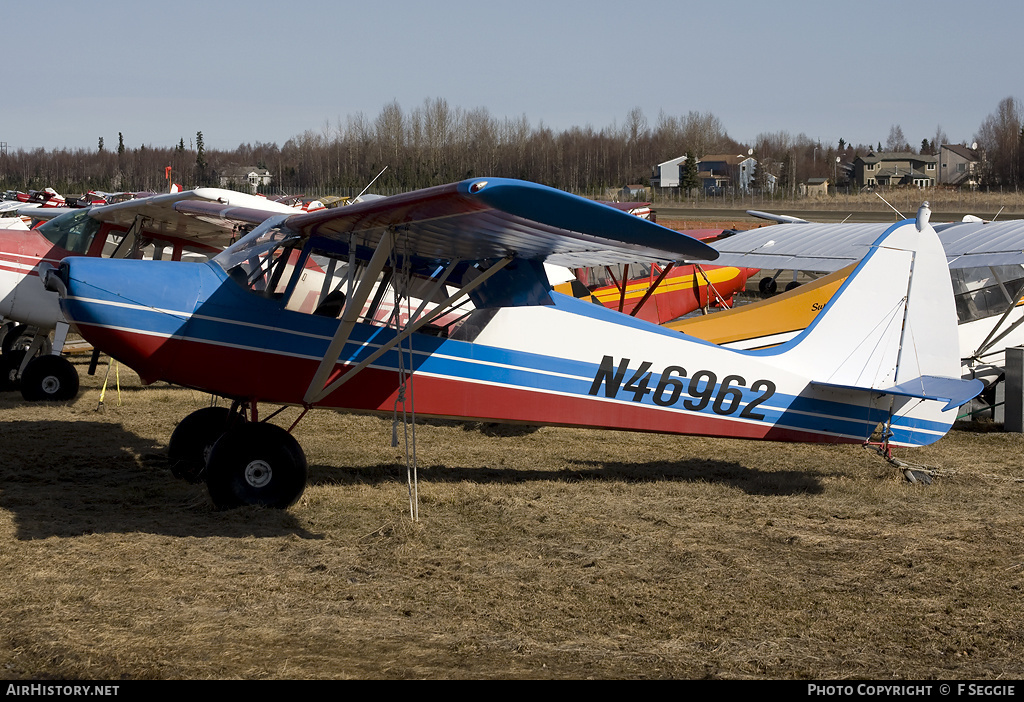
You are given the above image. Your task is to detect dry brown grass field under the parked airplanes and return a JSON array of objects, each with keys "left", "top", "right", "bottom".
[{"left": 0, "top": 358, "right": 1024, "bottom": 679}]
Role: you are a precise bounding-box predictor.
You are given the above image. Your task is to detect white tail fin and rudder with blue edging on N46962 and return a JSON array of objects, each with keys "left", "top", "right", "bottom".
[{"left": 760, "top": 203, "right": 983, "bottom": 445}]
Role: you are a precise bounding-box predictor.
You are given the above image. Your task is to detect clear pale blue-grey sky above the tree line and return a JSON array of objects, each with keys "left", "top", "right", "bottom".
[{"left": 0, "top": 0, "right": 1024, "bottom": 154}]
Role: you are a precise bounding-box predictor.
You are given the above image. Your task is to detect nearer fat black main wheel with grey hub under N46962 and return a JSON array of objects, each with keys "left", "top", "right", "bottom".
[{"left": 205, "top": 423, "right": 306, "bottom": 510}]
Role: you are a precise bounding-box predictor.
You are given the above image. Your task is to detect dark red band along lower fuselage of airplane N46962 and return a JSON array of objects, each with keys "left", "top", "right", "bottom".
[{"left": 80, "top": 324, "right": 862, "bottom": 443}]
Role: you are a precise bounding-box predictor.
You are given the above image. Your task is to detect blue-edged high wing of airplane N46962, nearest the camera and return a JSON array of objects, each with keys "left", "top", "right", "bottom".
[{"left": 274, "top": 178, "right": 718, "bottom": 267}]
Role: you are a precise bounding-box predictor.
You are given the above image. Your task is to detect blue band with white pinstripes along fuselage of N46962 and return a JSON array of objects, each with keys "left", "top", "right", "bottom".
[{"left": 59, "top": 261, "right": 948, "bottom": 443}]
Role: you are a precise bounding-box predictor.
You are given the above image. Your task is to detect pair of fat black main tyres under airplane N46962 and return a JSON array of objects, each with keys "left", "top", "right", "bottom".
[{"left": 168, "top": 403, "right": 307, "bottom": 510}]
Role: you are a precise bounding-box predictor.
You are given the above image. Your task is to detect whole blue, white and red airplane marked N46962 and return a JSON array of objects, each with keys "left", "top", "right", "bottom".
[{"left": 47, "top": 178, "right": 981, "bottom": 508}]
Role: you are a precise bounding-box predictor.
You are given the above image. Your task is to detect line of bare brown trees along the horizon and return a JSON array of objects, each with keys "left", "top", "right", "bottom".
[{"left": 0, "top": 97, "right": 1024, "bottom": 196}]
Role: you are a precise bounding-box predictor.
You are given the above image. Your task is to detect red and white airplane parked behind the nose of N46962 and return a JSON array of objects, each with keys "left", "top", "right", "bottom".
[{"left": 0, "top": 188, "right": 311, "bottom": 400}]
